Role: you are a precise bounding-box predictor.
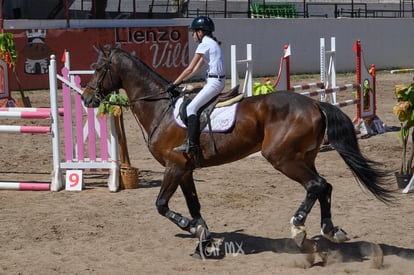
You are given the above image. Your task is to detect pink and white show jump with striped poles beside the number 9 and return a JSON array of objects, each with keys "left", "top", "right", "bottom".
[{"left": 0, "top": 52, "right": 119, "bottom": 192}]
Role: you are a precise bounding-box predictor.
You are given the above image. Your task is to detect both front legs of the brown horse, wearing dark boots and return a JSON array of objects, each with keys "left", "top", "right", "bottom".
[{"left": 156, "top": 167, "right": 210, "bottom": 240}]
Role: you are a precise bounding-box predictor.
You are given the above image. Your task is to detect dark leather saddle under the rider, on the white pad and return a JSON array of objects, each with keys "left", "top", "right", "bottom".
[{"left": 179, "top": 85, "right": 243, "bottom": 131}]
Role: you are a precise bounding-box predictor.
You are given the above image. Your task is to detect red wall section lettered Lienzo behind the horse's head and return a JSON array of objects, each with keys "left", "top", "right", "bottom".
[{"left": 9, "top": 26, "right": 188, "bottom": 90}]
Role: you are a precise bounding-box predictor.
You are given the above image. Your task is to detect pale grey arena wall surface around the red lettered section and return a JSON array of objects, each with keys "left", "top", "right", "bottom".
[{"left": 4, "top": 18, "right": 414, "bottom": 84}]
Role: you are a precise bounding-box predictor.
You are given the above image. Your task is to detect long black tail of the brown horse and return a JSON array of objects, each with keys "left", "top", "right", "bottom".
[{"left": 319, "top": 102, "right": 395, "bottom": 203}]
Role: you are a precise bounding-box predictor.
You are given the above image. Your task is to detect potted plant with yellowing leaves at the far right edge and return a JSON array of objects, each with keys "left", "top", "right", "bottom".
[{"left": 393, "top": 78, "right": 414, "bottom": 188}]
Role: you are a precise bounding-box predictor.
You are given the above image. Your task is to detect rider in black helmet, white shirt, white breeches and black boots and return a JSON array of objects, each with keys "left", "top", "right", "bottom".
[{"left": 167, "top": 16, "right": 225, "bottom": 155}]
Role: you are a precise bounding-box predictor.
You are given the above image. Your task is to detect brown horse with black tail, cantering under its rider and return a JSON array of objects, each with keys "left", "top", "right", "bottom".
[{"left": 83, "top": 43, "right": 393, "bottom": 256}]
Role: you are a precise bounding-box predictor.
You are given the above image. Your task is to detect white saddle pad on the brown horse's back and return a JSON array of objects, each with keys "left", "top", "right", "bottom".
[{"left": 173, "top": 97, "right": 239, "bottom": 132}]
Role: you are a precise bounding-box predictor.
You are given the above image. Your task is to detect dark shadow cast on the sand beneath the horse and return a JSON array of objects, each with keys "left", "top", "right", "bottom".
[{"left": 177, "top": 230, "right": 414, "bottom": 267}]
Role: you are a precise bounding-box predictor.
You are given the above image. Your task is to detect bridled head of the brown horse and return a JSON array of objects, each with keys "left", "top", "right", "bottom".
[{"left": 82, "top": 45, "right": 120, "bottom": 108}]
